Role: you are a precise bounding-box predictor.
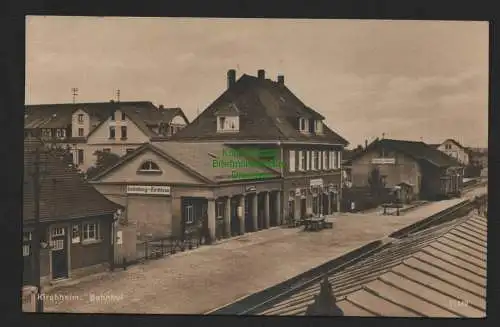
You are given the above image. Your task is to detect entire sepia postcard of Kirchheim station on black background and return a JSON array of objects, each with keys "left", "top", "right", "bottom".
[{"left": 21, "top": 15, "right": 490, "bottom": 318}]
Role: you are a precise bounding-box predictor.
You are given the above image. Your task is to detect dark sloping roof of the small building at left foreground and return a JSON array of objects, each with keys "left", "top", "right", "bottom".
[{"left": 23, "top": 139, "right": 121, "bottom": 222}]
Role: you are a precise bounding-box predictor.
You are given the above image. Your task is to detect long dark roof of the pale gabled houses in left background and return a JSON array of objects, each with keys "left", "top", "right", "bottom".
[{"left": 24, "top": 101, "right": 189, "bottom": 137}]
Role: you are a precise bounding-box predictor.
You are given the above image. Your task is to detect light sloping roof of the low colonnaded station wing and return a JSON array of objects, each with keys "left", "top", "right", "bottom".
[{"left": 93, "top": 141, "right": 280, "bottom": 184}]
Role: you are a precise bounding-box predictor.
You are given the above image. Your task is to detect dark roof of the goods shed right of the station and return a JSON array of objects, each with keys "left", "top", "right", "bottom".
[{"left": 351, "top": 139, "right": 461, "bottom": 167}]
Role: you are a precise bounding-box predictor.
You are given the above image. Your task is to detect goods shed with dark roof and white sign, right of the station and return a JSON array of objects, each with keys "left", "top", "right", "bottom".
[{"left": 351, "top": 139, "right": 463, "bottom": 199}]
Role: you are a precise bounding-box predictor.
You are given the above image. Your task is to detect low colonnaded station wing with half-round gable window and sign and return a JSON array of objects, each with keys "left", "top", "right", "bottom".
[{"left": 91, "top": 141, "right": 282, "bottom": 240}]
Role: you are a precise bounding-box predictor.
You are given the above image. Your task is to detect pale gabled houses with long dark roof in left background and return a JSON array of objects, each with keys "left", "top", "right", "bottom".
[{"left": 24, "top": 101, "right": 189, "bottom": 171}]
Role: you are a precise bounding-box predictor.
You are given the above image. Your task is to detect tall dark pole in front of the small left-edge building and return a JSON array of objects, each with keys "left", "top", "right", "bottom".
[{"left": 32, "top": 145, "right": 43, "bottom": 312}]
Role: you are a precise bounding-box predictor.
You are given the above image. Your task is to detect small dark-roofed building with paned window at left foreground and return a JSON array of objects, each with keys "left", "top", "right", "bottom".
[{"left": 22, "top": 140, "right": 121, "bottom": 285}]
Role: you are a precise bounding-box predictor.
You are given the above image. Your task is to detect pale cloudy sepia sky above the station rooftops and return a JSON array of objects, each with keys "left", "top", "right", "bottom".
[{"left": 25, "top": 16, "right": 489, "bottom": 147}]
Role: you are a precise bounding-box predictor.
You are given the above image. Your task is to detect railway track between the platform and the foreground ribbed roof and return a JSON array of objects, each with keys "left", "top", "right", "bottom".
[{"left": 209, "top": 192, "right": 486, "bottom": 315}]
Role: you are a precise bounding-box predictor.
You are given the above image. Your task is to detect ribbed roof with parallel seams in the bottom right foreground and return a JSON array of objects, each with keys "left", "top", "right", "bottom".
[{"left": 252, "top": 215, "right": 487, "bottom": 317}]
